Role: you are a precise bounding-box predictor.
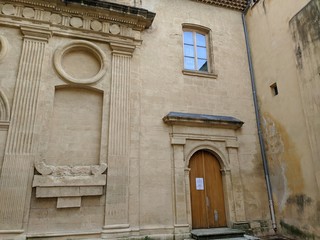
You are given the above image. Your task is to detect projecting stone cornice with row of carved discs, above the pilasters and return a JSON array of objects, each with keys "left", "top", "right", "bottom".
[{"left": 0, "top": 0, "right": 155, "bottom": 41}]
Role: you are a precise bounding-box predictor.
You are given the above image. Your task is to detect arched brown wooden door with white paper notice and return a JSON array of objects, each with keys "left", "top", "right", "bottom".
[{"left": 189, "top": 150, "right": 226, "bottom": 229}]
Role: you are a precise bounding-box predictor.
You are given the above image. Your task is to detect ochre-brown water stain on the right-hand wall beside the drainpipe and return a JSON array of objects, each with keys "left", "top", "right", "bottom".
[{"left": 262, "top": 113, "right": 304, "bottom": 212}]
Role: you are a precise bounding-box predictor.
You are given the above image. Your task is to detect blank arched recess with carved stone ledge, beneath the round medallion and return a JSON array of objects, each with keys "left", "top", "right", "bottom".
[{"left": 33, "top": 84, "right": 107, "bottom": 208}]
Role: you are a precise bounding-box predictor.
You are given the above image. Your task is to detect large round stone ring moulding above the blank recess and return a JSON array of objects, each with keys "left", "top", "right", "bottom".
[{"left": 54, "top": 40, "right": 107, "bottom": 84}]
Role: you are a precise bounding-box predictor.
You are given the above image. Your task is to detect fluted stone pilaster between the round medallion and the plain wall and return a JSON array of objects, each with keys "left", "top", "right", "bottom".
[{"left": 103, "top": 43, "right": 134, "bottom": 237}]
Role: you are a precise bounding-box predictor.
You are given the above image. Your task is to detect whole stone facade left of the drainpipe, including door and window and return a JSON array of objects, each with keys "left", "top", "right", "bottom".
[{"left": 0, "top": 0, "right": 317, "bottom": 239}]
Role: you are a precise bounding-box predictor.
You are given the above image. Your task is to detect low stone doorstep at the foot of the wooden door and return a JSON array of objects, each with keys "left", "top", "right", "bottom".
[{"left": 191, "top": 228, "right": 246, "bottom": 240}]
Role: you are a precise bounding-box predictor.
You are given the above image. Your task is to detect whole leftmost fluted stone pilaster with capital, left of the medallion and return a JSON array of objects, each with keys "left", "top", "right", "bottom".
[{"left": 0, "top": 27, "right": 51, "bottom": 230}]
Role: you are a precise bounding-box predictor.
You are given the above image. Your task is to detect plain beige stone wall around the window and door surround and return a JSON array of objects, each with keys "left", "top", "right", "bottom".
[{"left": 137, "top": 1, "right": 269, "bottom": 232}]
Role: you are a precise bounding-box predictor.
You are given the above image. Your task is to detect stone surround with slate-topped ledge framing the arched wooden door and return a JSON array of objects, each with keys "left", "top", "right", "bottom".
[{"left": 163, "top": 112, "right": 246, "bottom": 237}]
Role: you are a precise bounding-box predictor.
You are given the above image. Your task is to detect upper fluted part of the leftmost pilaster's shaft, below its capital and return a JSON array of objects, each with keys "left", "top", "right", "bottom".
[{"left": 6, "top": 39, "right": 45, "bottom": 154}]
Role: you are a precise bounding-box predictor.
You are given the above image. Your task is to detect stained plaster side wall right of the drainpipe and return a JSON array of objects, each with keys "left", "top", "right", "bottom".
[{"left": 246, "top": 0, "right": 320, "bottom": 235}]
